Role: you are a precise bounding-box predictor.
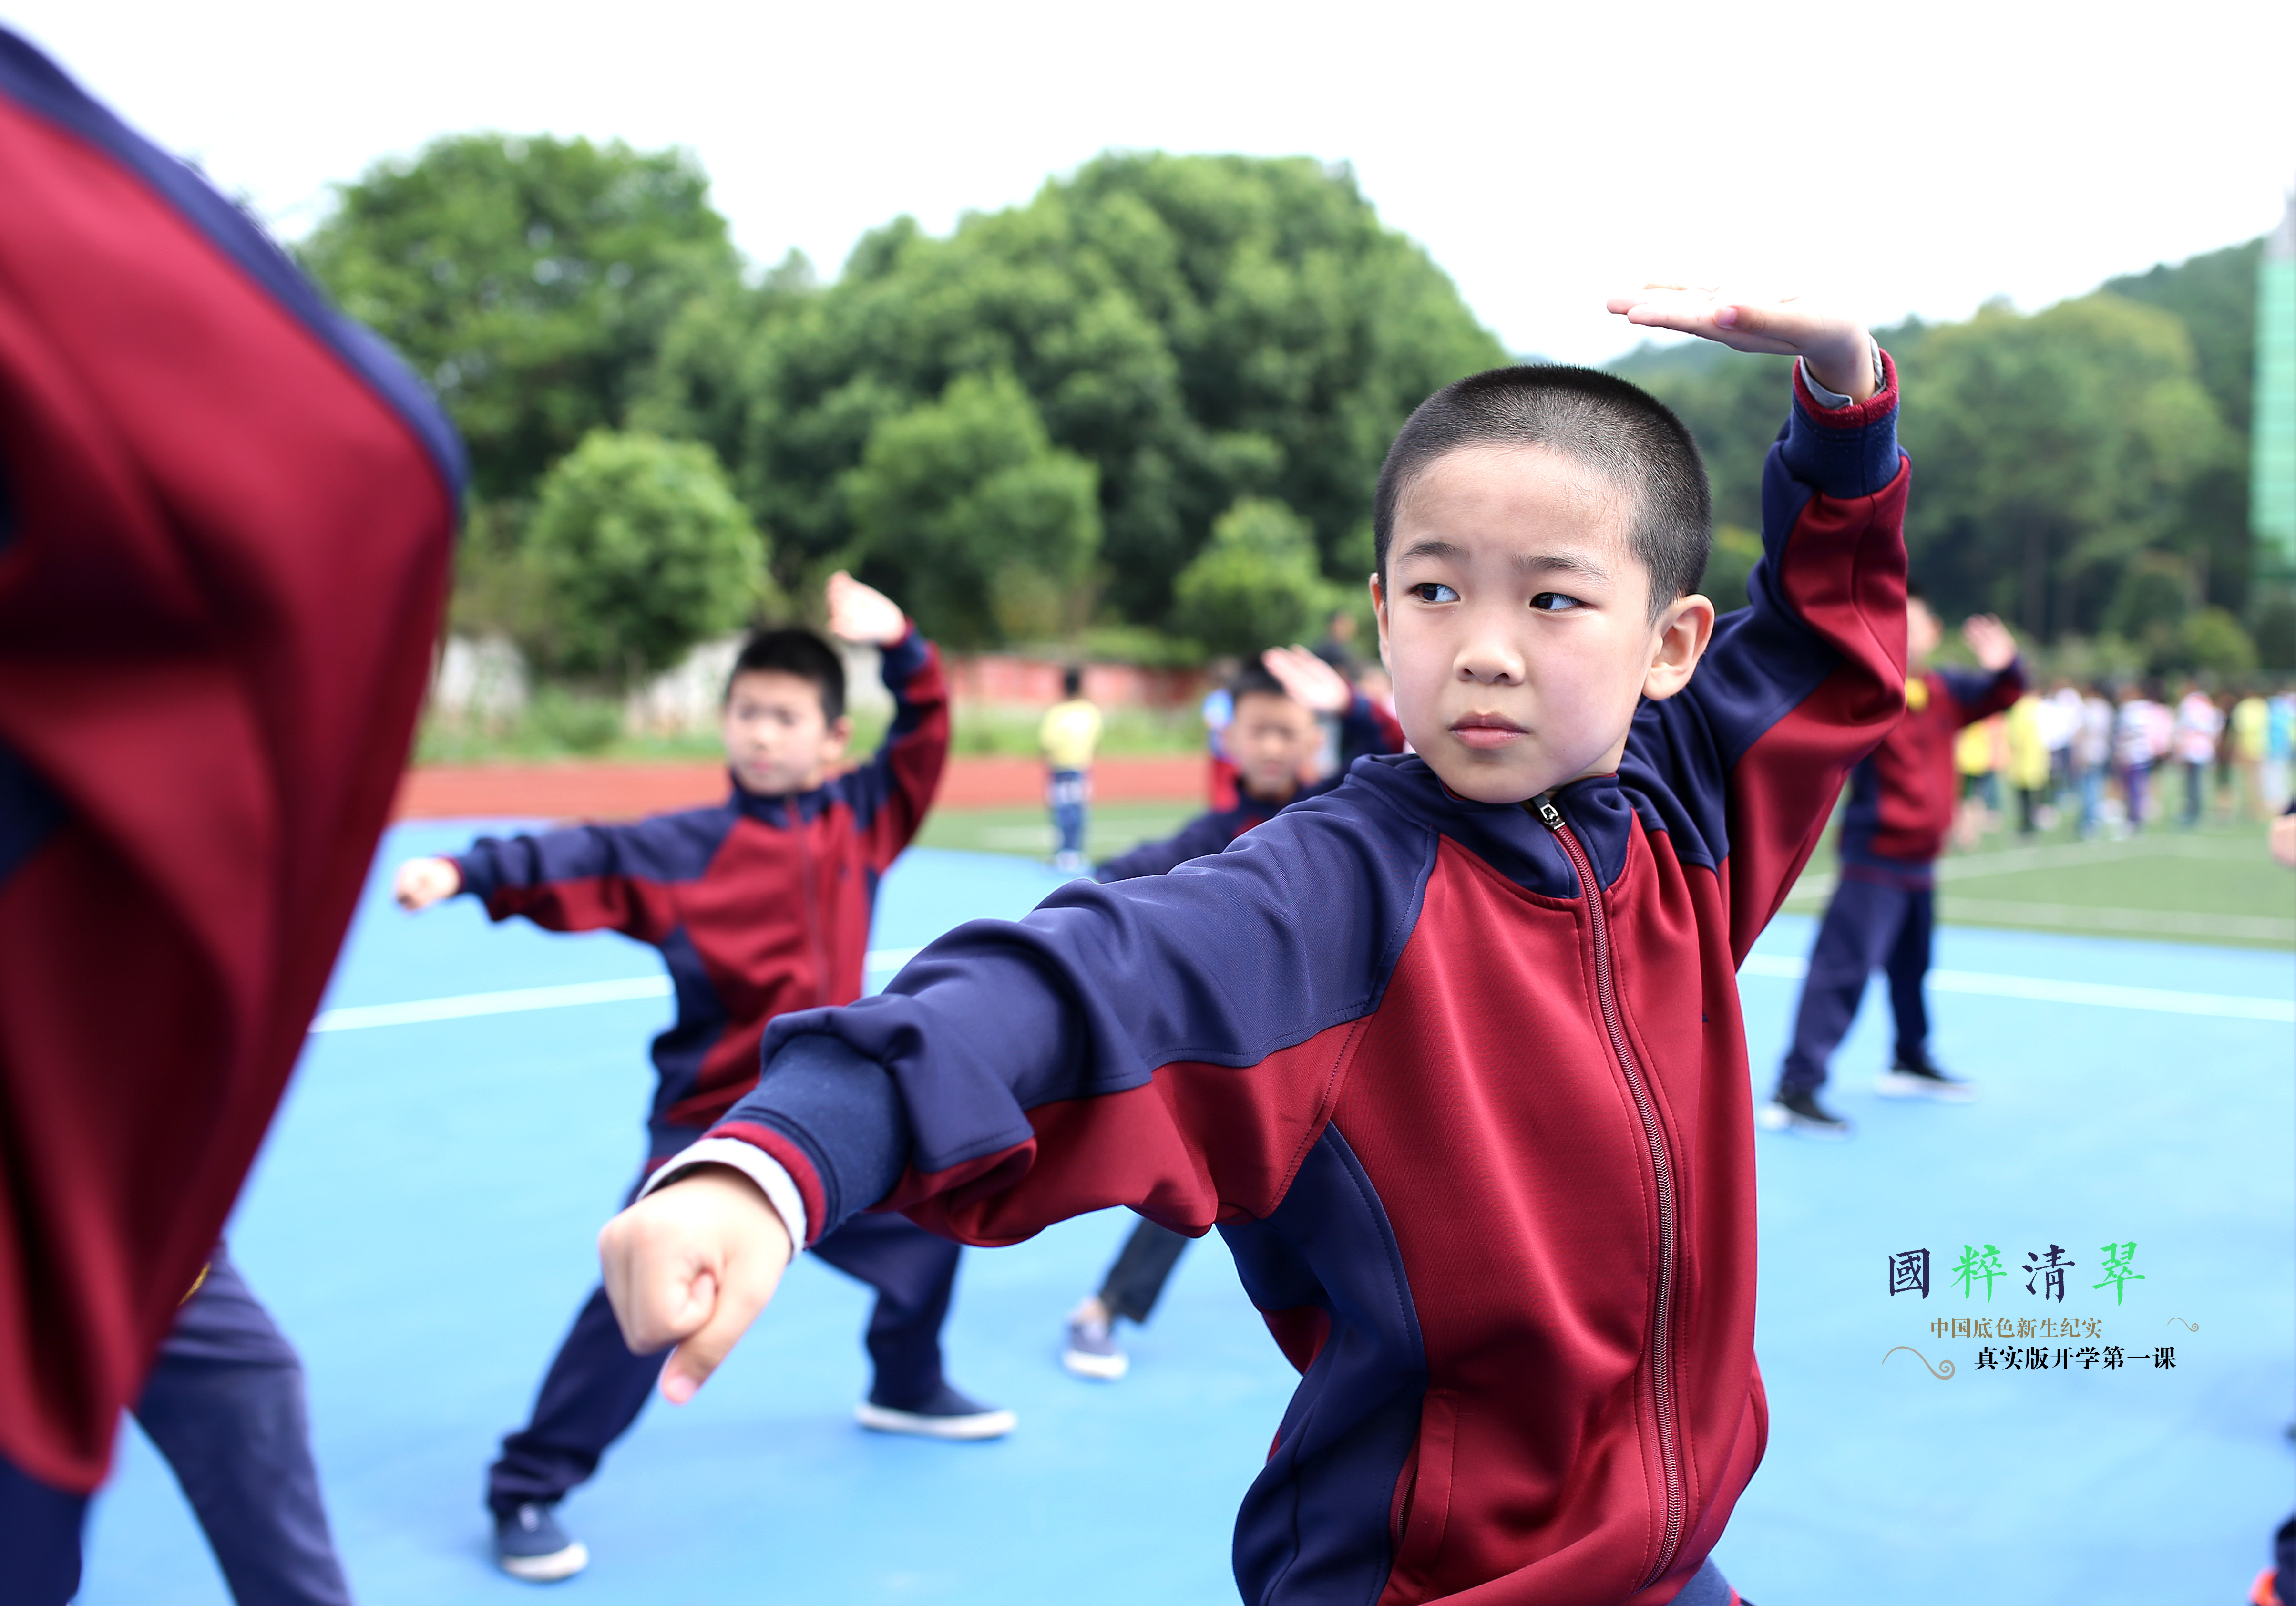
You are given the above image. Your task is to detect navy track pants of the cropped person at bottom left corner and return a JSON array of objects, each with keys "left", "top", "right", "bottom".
[{"left": 0, "top": 1246, "right": 351, "bottom": 1606}]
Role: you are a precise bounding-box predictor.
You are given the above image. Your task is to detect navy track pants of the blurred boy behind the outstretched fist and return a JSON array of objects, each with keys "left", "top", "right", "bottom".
[{"left": 487, "top": 1215, "right": 962, "bottom": 1512}]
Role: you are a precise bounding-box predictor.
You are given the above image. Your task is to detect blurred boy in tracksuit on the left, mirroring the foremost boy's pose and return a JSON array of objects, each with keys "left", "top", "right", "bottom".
[{"left": 400, "top": 575, "right": 1013, "bottom": 1578}]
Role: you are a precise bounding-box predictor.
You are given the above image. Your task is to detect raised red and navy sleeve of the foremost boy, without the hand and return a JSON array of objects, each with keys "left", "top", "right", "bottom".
[{"left": 1621, "top": 356, "right": 1908, "bottom": 958}]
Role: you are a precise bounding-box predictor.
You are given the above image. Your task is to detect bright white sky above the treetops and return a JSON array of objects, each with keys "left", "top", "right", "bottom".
[{"left": 0, "top": 0, "right": 2296, "bottom": 360}]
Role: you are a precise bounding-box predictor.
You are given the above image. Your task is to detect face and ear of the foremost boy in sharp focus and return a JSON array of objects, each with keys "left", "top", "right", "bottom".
[{"left": 1371, "top": 446, "right": 1715, "bottom": 802}]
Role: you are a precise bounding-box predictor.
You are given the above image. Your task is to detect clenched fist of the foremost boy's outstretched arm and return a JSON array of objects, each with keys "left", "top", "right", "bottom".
[{"left": 597, "top": 1165, "right": 794, "bottom": 1406}]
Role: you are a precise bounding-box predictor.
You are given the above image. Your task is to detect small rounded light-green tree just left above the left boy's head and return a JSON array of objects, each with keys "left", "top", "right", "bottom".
[{"left": 521, "top": 430, "right": 765, "bottom": 687}]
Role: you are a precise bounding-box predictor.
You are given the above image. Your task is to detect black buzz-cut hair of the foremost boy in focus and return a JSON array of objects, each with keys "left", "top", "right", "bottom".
[{"left": 1371, "top": 363, "right": 1713, "bottom": 620}]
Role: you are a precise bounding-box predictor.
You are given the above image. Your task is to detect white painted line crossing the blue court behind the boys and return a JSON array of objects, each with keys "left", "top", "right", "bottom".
[{"left": 310, "top": 949, "right": 2296, "bottom": 1031}]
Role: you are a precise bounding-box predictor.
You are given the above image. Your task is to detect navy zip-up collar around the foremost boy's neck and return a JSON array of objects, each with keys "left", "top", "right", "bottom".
[{"left": 1345, "top": 753, "right": 1635, "bottom": 898}]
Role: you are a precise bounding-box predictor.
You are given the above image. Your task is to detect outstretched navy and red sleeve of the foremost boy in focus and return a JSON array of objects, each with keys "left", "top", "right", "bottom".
[{"left": 714, "top": 800, "right": 1435, "bottom": 1243}]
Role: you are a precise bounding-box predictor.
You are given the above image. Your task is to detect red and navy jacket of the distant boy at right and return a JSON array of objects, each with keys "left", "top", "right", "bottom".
[{"left": 1841, "top": 659, "right": 2025, "bottom": 882}]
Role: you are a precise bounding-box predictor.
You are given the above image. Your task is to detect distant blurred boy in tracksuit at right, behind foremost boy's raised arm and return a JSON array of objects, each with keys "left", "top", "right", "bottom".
[{"left": 1761, "top": 586, "right": 2025, "bottom": 1137}]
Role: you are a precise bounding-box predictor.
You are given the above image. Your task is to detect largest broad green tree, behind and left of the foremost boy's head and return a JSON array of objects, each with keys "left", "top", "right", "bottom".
[{"left": 656, "top": 154, "right": 1504, "bottom": 623}]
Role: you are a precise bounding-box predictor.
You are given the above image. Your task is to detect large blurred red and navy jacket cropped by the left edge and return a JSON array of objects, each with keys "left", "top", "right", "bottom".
[{"left": 0, "top": 30, "right": 461, "bottom": 1498}]
